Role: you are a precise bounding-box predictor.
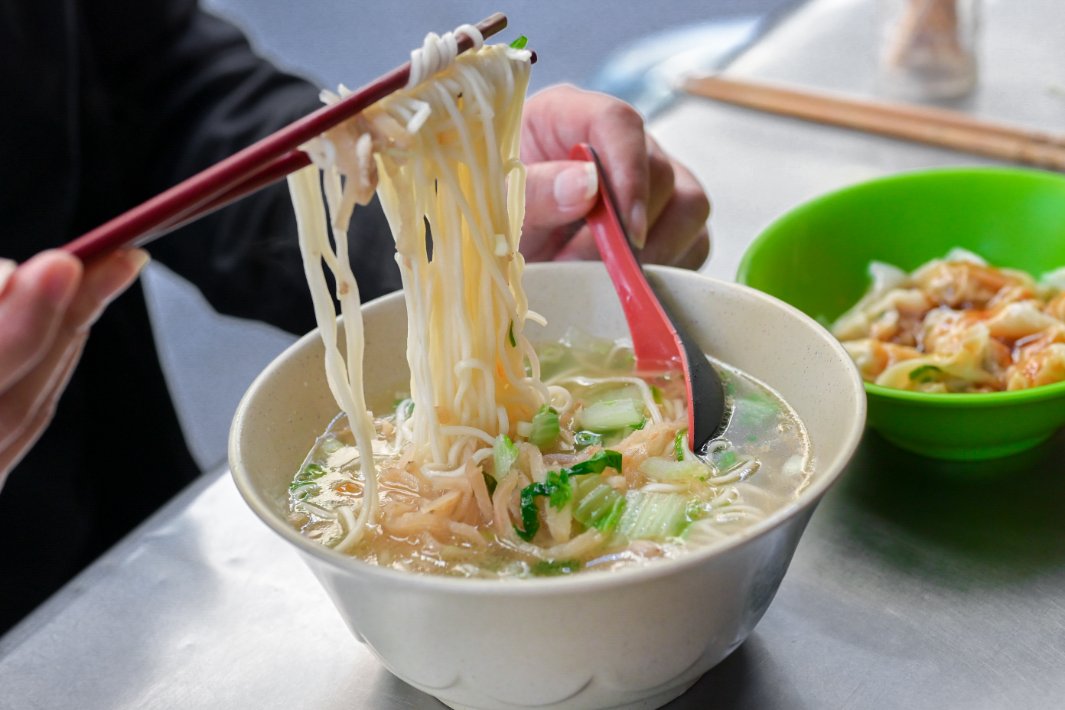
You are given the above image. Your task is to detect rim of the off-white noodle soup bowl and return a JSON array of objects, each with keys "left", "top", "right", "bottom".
[{"left": 229, "top": 262, "right": 867, "bottom": 597}]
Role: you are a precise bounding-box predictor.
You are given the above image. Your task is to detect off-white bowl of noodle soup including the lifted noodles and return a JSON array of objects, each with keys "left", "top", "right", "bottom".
[{"left": 230, "top": 29, "right": 865, "bottom": 709}]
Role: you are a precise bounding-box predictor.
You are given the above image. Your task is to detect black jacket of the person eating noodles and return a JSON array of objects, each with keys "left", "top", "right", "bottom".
[{"left": 0, "top": 0, "right": 399, "bottom": 632}]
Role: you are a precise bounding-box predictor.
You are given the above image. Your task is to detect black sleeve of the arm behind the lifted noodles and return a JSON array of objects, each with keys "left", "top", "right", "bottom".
[{"left": 85, "top": 0, "right": 399, "bottom": 332}]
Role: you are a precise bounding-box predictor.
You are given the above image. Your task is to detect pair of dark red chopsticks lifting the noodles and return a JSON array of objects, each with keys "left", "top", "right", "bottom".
[{"left": 63, "top": 13, "right": 507, "bottom": 261}]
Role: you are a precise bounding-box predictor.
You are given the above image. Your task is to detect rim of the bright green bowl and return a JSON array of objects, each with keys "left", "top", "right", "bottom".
[{"left": 736, "top": 165, "right": 1065, "bottom": 409}]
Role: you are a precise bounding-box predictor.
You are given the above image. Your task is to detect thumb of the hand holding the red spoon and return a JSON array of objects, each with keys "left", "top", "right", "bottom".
[{"left": 525, "top": 161, "right": 599, "bottom": 230}]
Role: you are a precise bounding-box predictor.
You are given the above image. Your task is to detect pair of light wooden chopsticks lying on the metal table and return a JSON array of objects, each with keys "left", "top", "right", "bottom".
[{"left": 683, "top": 75, "right": 1065, "bottom": 170}]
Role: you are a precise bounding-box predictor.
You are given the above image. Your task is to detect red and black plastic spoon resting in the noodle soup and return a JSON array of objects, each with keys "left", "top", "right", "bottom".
[{"left": 570, "top": 143, "right": 726, "bottom": 453}]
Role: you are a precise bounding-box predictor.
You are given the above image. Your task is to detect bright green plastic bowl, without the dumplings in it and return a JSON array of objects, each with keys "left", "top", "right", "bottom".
[{"left": 737, "top": 168, "right": 1065, "bottom": 460}]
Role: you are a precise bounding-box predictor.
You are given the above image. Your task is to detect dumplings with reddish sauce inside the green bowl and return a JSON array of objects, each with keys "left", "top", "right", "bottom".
[{"left": 832, "top": 249, "right": 1065, "bottom": 393}]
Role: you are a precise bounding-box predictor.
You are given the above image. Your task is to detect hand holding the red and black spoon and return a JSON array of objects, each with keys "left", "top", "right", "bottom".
[{"left": 522, "top": 86, "right": 710, "bottom": 268}]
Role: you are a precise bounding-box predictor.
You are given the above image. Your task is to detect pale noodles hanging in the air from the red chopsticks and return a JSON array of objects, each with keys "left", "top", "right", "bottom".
[{"left": 290, "top": 31, "right": 532, "bottom": 548}]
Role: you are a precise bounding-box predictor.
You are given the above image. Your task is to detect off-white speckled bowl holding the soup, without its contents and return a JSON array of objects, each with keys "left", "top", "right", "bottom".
[{"left": 229, "top": 263, "right": 865, "bottom": 710}]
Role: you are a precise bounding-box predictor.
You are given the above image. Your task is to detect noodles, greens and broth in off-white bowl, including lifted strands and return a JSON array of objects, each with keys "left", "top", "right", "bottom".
[{"left": 290, "top": 28, "right": 808, "bottom": 576}]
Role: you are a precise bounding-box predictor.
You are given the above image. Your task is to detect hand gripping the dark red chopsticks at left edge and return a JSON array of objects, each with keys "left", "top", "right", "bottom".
[{"left": 0, "top": 249, "right": 148, "bottom": 488}]
